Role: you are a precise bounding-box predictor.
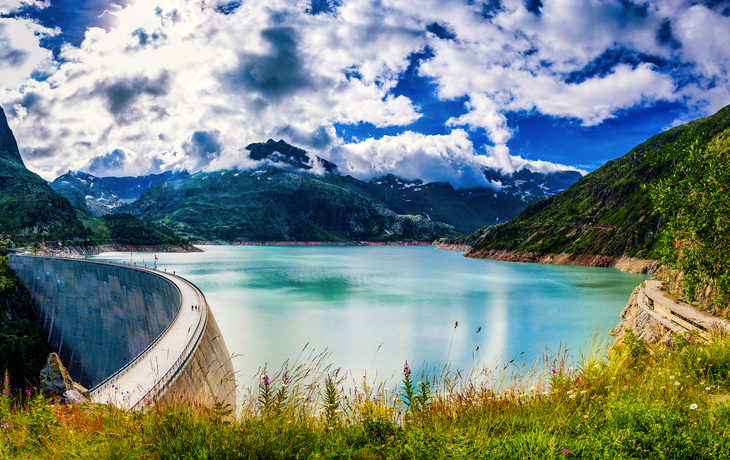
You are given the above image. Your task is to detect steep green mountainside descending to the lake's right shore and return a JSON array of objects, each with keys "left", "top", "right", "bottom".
[{"left": 464, "top": 106, "right": 730, "bottom": 258}]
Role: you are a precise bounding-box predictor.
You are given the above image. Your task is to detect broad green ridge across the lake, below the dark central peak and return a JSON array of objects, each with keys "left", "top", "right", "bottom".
[{"left": 120, "top": 167, "right": 458, "bottom": 242}]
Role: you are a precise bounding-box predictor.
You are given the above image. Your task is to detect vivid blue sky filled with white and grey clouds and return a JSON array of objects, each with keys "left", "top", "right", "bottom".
[{"left": 0, "top": 0, "right": 730, "bottom": 187}]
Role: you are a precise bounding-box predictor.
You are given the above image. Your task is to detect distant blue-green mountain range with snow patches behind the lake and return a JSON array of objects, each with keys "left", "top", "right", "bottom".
[{"left": 45, "top": 139, "right": 581, "bottom": 242}]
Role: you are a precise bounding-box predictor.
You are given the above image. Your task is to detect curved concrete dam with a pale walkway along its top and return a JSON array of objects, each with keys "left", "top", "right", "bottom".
[{"left": 8, "top": 255, "right": 236, "bottom": 409}]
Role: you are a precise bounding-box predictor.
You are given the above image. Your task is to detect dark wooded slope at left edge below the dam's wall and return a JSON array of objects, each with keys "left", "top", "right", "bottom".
[{"left": 0, "top": 257, "right": 51, "bottom": 389}]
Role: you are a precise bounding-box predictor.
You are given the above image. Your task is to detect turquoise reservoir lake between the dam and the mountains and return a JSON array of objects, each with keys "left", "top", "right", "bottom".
[{"left": 92, "top": 246, "right": 648, "bottom": 386}]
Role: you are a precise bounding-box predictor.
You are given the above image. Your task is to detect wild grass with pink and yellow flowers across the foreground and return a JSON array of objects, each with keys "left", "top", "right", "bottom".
[{"left": 0, "top": 334, "right": 730, "bottom": 459}]
